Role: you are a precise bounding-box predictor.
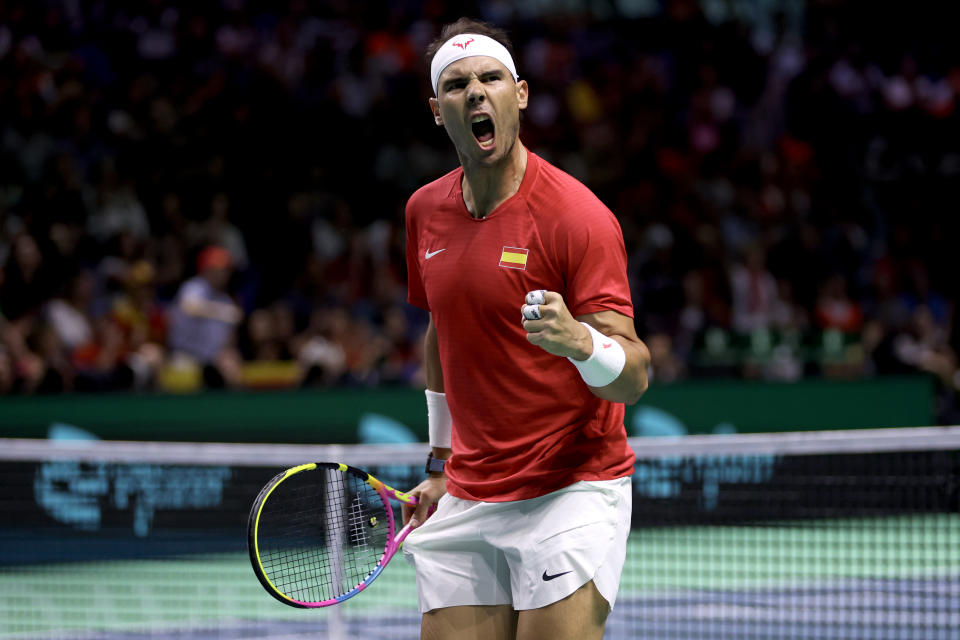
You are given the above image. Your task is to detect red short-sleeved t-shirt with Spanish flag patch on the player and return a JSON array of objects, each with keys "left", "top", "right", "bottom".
[{"left": 406, "top": 153, "right": 634, "bottom": 502}]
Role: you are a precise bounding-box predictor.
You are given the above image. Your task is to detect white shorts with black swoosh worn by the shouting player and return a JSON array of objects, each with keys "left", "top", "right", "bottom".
[{"left": 403, "top": 478, "right": 632, "bottom": 613}]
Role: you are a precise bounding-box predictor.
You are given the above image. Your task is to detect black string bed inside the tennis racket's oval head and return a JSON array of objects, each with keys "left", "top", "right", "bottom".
[{"left": 258, "top": 471, "right": 388, "bottom": 602}]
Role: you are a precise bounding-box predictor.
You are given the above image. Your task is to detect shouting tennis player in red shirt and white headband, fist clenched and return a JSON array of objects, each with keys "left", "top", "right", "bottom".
[{"left": 404, "top": 19, "right": 650, "bottom": 640}]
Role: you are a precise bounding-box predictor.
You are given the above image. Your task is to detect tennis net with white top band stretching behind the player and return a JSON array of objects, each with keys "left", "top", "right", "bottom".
[{"left": 0, "top": 427, "right": 960, "bottom": 640}]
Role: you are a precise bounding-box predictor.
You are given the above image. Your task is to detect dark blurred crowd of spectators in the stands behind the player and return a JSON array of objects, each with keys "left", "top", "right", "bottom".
[{"left": 0, "top": 0, "right": 960, "bottom": 411}]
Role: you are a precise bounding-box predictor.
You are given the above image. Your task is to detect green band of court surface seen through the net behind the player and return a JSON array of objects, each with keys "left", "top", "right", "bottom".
[{"left": 0, "top": 514, "right": 960, "bottom": 639}]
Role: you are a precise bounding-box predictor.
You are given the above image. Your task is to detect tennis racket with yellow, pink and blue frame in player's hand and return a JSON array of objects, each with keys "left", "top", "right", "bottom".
[{"left": 247, "top": 462, "right": 417, "bottom": 608}]
